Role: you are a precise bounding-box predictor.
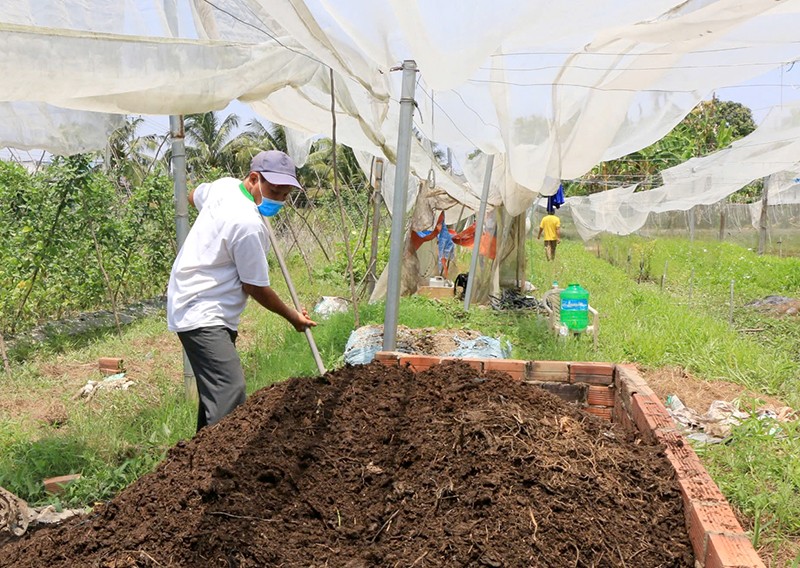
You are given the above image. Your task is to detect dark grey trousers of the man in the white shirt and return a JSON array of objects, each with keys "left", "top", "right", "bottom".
[{"left": 178, "top": 325, "right": 246, "bottom": 431}]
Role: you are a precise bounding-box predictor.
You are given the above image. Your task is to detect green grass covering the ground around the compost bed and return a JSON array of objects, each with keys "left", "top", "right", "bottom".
[{"left": 0, "top": 234, "right": 800, "bottom": 557}]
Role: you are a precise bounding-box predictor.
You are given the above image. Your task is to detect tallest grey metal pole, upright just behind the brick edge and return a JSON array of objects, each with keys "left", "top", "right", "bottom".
[{"left": 383, "top": 59, "right": 417, "bottom": 351}]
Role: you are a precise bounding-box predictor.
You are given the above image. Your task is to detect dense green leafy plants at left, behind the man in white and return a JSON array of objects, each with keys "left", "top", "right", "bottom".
[{"left": 0, "top": 155, "right": 175, "bottom": 333}]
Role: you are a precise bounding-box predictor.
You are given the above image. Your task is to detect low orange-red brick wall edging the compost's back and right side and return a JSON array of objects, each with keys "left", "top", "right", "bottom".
[{"left": 375, "top": 351, "right": 766, "bottom": 568}]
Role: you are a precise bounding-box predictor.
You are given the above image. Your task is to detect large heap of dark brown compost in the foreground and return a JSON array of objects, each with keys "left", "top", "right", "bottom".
[{"left": 0, "top": 362, "right": 694, "bottom": 568}]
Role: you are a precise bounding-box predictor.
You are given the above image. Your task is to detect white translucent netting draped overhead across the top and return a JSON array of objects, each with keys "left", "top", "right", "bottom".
[{"left": 0, "top": 0, "right": 800, "bottom": 215}]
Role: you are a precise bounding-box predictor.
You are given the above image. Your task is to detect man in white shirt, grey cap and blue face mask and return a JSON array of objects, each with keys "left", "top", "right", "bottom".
[{"left": 167, "top": 150, "right": 317, "bottom": 430}]
